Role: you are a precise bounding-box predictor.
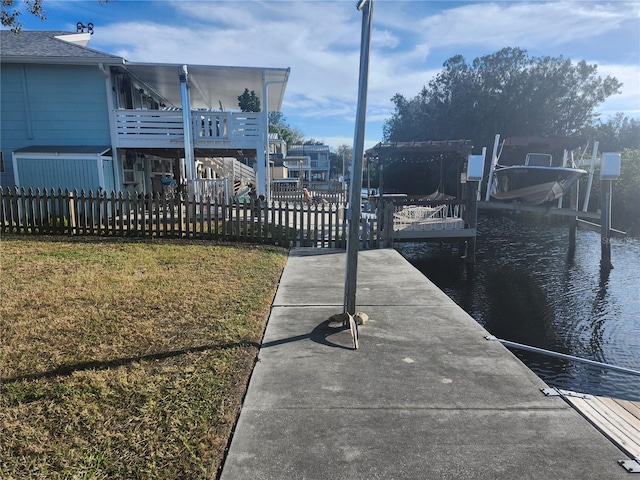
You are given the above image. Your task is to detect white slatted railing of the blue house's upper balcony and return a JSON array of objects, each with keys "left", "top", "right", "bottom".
[{"left": 113, "top": 109, "right": 264, "bottom": 148}]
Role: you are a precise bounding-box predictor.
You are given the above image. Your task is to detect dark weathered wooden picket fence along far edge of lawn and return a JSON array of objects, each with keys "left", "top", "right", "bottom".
[{"left": 0, "top": 189, "right": 393, "bottom": 249}]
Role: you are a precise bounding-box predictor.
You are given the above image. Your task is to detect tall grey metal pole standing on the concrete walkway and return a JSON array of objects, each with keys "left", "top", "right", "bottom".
[{"left": 343, "top": 0, "right": 373, "bottom": 315}]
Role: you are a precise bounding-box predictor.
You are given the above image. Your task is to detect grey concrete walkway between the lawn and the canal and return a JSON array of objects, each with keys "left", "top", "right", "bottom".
[{"left": 221, "top": 249, "right": 630, "bottom": 480}]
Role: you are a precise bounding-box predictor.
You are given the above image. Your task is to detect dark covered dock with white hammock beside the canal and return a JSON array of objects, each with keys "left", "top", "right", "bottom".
[{"left": 365, "top": 140, "right": 478, "bottom": 263}]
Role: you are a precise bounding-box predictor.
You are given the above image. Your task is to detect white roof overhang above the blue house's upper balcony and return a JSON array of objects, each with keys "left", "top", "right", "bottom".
[{"left": 125, "top": 62, "right": 290, "bottom": 111}]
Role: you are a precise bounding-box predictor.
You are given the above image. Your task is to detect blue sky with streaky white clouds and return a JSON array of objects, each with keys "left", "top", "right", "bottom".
[{"left": 16, "top": 0, "right": 640, "bottom": 148}]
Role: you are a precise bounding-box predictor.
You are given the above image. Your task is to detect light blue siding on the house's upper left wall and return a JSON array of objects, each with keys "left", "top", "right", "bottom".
[{"left": 0, "top": 63, "right": 111, "bottom": 188}]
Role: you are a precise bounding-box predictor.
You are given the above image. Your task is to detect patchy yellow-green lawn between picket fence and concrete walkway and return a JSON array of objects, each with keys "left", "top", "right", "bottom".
[{"left": 0, "top": 235, "right": 287, "bottom": 480}]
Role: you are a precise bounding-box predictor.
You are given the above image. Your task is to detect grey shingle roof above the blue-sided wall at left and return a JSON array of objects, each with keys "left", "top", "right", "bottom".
[{"left": 0, "top": 30, "right": 123, "bottom": 63}]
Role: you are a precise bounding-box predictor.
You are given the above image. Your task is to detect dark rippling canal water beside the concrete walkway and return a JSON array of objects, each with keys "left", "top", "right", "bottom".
[{"left": 397, "top": 214, "right": 640, "bottom": 401}]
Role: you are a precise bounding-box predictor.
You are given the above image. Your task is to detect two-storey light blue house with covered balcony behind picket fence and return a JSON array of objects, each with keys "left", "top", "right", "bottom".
[{"left": 0, "top": 30, "right": 289, "bottom": 199}]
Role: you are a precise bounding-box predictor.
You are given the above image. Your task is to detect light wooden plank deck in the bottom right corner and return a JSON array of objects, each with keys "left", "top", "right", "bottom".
[{"left": 545, "top": 388, "right": 640, "bottom": 473}]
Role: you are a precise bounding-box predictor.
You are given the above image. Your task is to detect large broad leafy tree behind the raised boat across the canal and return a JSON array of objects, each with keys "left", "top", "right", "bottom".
[{"left": 383, "top": 48, "right": 621, "bottom": 152}]
